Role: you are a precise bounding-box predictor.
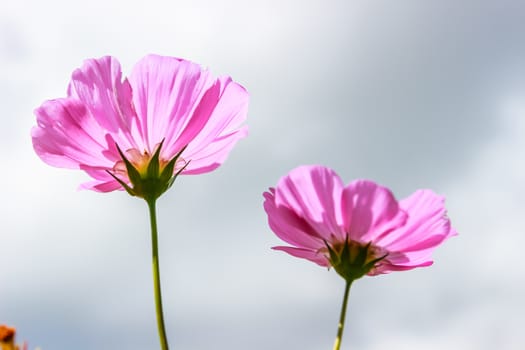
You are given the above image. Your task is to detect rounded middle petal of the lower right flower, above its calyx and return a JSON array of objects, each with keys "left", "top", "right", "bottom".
[{"left": 343, "top": 180, "right": 406, "bottom": 245}]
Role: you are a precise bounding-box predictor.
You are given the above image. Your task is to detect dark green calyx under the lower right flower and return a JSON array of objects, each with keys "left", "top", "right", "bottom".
[{"left": 325, "top": 236, "right": 388, "bottom": 282}]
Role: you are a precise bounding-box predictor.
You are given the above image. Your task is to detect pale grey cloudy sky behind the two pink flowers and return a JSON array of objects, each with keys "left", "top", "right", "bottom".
[{"left": 0, "top": 0, "right": 525, "bottom": 350}]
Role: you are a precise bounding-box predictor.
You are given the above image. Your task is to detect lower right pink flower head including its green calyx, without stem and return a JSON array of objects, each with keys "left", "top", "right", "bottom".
[{"left": 264, "top": 166, "right": 456, "bottom": 281}]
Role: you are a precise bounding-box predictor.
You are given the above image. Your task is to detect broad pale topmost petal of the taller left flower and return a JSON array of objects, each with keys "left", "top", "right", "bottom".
[{"left": 129, "top": 55, "right": 215, "bottom": 159}]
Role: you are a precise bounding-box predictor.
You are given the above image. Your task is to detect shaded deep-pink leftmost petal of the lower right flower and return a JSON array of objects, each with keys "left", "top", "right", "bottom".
[{"left": 263, "top": 188, "right": 325, "bottom": 251}]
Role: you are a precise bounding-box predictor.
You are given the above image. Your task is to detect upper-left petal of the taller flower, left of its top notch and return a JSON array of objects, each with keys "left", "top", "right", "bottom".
[{"left": 68, "top": 56, "right": 141, "bottom": 150}]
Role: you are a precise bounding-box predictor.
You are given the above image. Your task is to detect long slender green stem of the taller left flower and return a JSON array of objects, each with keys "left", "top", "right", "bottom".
[{"left": 146, "top": 199, "right": 168, "bottom": 350}]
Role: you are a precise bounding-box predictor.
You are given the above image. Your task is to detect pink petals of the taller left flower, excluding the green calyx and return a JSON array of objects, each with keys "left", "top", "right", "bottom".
[{"left": 31, "top": 55, "right": 248, "bottom": 192}]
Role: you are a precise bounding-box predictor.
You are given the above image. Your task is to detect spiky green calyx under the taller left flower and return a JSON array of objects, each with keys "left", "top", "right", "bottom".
[{"left": 107, "top": 140, "right": 189, "bottom": 201}]
